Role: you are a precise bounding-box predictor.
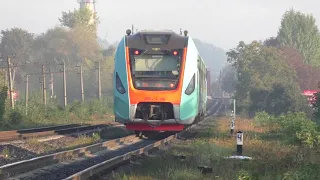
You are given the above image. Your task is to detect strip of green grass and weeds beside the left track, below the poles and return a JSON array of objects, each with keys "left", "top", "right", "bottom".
[{"left": 0, "top": 94, "right": 113, "bottom": 130}]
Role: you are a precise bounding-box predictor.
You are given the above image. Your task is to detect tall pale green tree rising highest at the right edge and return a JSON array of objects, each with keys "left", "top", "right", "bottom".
[{"left": 278, "top": 9, "right": 320, "bottom": 66}]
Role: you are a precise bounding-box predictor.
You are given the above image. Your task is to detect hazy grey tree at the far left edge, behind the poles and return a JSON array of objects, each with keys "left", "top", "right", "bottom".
[{"left": 0, "top": 28, "right": 34, "bottom": 85}]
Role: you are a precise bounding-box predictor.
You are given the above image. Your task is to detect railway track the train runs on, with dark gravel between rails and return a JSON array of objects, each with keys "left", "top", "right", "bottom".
[{"left": 0, "top": 97, "right": 226, "bottom": 180}]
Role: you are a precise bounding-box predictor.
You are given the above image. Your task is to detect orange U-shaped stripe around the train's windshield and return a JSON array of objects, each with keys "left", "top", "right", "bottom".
[{"left": 126, "top": 47, "right": 187, "bottom": 105}]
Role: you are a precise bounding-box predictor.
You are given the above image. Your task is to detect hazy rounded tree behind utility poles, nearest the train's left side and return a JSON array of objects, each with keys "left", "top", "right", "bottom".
[{"left": 28, "top": 25, "right": 105, "bottom": 102}]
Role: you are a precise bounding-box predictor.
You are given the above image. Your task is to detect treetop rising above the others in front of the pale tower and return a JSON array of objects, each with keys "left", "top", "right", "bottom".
[{"left": 59, "top": 8, "right": 99, "bottom": 35}]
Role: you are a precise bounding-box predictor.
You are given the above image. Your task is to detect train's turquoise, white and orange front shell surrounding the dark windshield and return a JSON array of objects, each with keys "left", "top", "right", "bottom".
[{"left": 114, "top": 31, "right": 203, "bottom": 131}]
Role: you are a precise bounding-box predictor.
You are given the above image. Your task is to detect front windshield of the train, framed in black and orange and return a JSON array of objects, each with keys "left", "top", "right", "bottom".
[{"left": 131, "top": 54, "right": 181, "bottom": 90}]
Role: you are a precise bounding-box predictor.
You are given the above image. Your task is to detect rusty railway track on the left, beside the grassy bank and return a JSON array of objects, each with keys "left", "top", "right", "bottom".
[{"left": 0, "top": 123, "right": 119, "bottom": 142}]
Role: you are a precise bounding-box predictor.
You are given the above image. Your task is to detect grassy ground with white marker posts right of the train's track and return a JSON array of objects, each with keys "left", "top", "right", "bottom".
[{"left": 116, "top": 113, "right": 320, "bottom": 180}]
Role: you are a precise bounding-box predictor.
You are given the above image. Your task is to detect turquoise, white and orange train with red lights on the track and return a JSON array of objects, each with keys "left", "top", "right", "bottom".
[{"left": 113, "top": 29, "right": 207, "bottom": 136}]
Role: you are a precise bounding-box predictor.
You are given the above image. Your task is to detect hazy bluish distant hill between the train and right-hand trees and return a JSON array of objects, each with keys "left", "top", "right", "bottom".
[{"left": 193, "top": 39, "right": 227, "bottom": 80}]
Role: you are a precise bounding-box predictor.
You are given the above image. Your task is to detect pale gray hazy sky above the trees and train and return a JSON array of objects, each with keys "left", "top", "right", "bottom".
[{"left": 0, "top": 0, "right": 320, "bottom": 49}]
